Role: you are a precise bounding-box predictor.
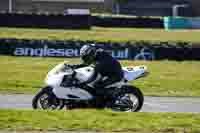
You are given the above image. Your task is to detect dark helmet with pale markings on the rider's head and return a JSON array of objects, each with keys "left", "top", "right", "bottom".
[{"left": 80, "top": 44, "right": 96, "bottom": 65}]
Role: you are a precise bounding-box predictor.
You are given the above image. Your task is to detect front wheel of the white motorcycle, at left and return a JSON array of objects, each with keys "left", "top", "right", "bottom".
[{"left": 32, "top": 86, "right": 64, "bottom": 110}]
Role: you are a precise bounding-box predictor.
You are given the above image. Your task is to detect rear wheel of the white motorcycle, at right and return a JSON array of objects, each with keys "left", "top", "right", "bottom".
[{"left": 112, "top": 86, "right": 144, "bottom": 112}]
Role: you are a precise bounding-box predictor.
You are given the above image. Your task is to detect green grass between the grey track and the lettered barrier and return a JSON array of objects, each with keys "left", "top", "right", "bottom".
[{"left": 0, "top": 56, "right": 200, "bottom": 96}]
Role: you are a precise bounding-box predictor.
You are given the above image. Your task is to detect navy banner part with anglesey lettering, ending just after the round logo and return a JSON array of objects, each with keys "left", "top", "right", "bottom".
[{"left": 0, "top": 39, "right": 154, "bottom": 60}]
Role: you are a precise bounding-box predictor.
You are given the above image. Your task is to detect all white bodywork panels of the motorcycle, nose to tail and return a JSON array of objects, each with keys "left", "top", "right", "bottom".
[{"left": 45, "top": 66, "right": 147, "bottom": 100}]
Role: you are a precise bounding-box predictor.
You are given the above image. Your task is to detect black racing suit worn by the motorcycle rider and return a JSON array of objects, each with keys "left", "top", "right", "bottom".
[{"left": 67, "top": 49, "right": 123, "bottom": 89}]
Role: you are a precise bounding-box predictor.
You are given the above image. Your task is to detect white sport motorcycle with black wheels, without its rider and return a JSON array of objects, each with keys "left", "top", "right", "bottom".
[{"left": 32, "top": 64, "right": 148, "bottom": 112}]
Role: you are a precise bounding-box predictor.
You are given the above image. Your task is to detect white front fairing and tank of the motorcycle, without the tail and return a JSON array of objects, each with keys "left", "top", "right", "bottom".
[{"left": 45, "top": 67, "right": 93, "bottom": 100}]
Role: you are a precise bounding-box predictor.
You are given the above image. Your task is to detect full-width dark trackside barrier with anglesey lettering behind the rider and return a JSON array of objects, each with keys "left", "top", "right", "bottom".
[{"left": 0, "top": 39, "right": 200, "bottom": 60}]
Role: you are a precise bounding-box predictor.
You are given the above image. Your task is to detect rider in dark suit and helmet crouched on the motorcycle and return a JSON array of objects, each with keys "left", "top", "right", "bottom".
[{"left": 66, "top": 44, "right": 123, "bottom": 96}]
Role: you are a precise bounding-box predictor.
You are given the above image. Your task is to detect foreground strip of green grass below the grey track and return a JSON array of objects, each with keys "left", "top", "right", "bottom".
[{"left": 0, "top": 110, "right": 200, "bottom": 133}]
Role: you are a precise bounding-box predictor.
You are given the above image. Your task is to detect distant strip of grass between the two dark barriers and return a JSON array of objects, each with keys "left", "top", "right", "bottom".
[{"left": 0, "top": 27, "right": 200, "bottom": 42}]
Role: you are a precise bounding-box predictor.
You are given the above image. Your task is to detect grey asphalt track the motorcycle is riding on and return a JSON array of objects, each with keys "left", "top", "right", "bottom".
[{"left": 0, "top": 94, "right": 200, "bottom": 113}]
